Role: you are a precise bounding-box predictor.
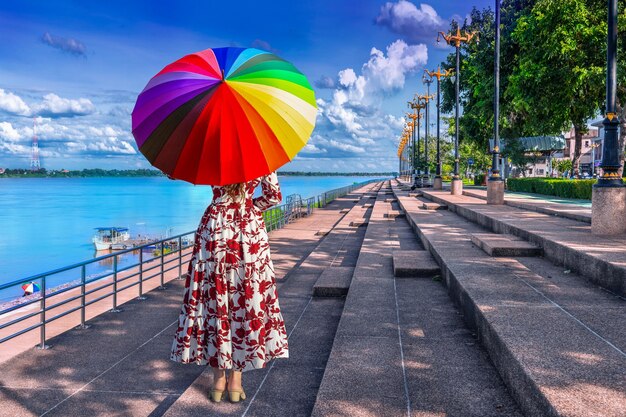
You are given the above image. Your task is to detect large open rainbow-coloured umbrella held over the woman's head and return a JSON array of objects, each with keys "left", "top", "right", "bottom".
[{"left": 132, "top": 48, "right": 317, "bottom": 185}]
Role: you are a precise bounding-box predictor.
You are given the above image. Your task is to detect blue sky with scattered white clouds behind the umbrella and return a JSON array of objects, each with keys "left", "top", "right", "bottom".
[{"left": 0, "top": 0, "right": 493, "bottom": 171}]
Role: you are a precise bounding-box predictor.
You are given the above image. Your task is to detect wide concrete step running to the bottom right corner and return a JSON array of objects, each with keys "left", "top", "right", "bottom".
[{"left": 390, "top": 182, "right": 626, "bottom": 417}]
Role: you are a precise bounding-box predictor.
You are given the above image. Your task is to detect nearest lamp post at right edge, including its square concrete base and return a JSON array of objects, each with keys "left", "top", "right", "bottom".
[{"left": 591, "top": 0, "right": 626, "bottom": 235}]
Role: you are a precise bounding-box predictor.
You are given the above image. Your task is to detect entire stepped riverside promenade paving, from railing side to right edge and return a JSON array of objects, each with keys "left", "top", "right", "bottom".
[{"left": 0, "top": 180, "right": 626, "bottom": 417}]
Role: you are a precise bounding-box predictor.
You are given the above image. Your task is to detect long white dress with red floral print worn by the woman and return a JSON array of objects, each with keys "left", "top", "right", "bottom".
[{"left": 170, "top": 173, "right": 289, "bottom": 371}]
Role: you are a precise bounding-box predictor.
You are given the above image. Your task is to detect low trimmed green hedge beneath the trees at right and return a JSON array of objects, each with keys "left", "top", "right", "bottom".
[{"left": 506, "top": 178, "right": 596, "bottom": 200}]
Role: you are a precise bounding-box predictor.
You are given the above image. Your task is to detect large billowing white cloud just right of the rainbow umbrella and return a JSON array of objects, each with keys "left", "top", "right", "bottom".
[{"left": 304, "top": 40, "right": 428, "bottom": 166}]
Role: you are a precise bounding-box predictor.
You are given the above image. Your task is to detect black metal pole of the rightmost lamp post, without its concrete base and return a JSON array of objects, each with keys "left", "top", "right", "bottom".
[{"left": 594, "top": 0, "right": 624, "bottom": 187}]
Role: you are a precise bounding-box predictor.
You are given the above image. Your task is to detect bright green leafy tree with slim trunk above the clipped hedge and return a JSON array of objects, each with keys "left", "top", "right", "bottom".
[{"left": 505, "top": 0, "right": 606, "bottom": 174}]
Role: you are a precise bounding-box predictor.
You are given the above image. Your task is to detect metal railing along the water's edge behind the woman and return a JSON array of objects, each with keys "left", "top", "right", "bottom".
[{"left": 0, "top": 180, "right": 379, "bottom": 349}]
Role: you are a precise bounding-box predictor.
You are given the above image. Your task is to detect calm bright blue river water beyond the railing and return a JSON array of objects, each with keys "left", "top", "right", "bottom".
[{"left": 0, "top": 176, "right": 380, "bottom": 301}]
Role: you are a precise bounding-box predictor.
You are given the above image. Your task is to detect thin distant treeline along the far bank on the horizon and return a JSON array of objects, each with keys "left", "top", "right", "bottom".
[{"left": 0, "top": 168, "right": 394, "bottom": 178}]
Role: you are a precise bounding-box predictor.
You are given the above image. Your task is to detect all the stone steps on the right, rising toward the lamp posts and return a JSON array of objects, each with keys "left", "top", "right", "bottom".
[{"left": 393, "top": 179, "right": 626, "bottom": 417}]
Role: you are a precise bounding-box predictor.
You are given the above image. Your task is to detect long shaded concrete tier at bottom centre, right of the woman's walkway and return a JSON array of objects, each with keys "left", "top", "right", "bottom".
[{"left": 311, "top": 180, "right": 520, "bottom": 417}]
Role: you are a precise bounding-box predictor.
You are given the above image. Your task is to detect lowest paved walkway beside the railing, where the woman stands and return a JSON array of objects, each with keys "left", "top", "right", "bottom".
[{"left": 0, "top": 185, "right": 373, "bottom": 417}]
